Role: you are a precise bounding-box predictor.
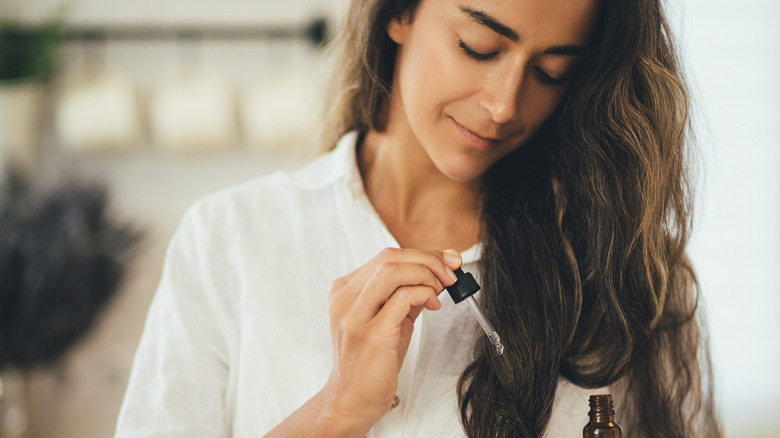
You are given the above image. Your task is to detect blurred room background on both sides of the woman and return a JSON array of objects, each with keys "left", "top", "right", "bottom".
[{"left": 0, "top": 0, "right": 780, "bottom": 438}]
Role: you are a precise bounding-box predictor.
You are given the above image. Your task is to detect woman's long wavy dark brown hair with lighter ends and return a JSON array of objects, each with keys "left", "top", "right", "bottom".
[{"left": 324, "top": 0, "right": 720, "bottom": 438}]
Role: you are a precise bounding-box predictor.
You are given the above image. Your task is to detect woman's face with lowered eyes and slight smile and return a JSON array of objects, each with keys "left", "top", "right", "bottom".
[{"left": 387, "top": 0, "right": 597, "bottom": 181}]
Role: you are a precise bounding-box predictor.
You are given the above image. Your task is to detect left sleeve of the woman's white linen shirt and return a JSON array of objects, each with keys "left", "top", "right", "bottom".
[{"left": 115, "top": 207, "right": 231, "bottom": 438}]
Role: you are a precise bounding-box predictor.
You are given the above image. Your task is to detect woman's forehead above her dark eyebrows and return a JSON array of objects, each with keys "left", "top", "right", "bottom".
[{"left": 419, "top": 0, "right": 600, "bottom": 45}]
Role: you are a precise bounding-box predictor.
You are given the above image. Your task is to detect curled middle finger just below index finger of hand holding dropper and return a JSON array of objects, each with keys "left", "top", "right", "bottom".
[{"left": 354, "top": 263, "right": 444, "bottom": 322}]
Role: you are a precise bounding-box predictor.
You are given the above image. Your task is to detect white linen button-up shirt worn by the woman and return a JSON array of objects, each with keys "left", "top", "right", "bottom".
[{"left": 115, "top": 132, "right": 603, "bottom": 438}]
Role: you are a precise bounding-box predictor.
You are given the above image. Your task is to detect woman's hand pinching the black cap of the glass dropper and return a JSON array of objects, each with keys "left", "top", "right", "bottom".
[{"left": 323, "top": 248, "right": 461, "bottom": 430}]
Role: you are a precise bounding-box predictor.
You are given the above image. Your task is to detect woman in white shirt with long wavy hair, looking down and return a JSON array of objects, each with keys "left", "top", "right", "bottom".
[{"left": 117, "top": 0, "right": 719, "bottom": 437}]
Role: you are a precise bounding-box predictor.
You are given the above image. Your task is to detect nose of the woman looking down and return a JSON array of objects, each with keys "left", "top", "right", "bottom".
[{"left": 479, "top": 62, "right": 525, "bottom": 124}]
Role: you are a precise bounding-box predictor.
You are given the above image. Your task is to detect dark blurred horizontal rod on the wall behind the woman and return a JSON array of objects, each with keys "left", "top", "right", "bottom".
[{"left": 60, "top": 18, "right": 328, "bottom": 46}]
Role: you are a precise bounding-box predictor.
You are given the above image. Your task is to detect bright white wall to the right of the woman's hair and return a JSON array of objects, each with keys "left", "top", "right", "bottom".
[{"left": 675, "top": 0, "right": 780, "bottom": 438}]
